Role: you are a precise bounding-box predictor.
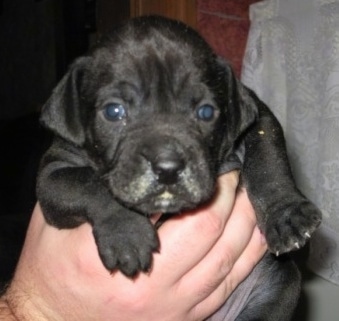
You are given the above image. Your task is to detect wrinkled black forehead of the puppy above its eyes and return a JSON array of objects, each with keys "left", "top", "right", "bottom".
[{"left": 91, "top": 31, "right": 211, "bottom": 99}]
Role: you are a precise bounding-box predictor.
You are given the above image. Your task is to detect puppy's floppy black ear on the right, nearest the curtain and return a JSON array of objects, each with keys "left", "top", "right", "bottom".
[{"left": 218, "top": 58, "right": 259, "bottom": 142}]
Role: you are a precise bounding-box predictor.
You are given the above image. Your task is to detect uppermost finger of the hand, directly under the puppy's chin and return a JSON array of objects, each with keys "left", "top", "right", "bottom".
[{"left": 152, "top": 172, "right": 239, "bottom": 282}]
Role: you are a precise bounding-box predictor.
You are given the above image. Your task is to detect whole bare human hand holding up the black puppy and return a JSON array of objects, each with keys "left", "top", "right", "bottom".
[{"left": 5, "top": 172, "right": 266, "bottom": 321}]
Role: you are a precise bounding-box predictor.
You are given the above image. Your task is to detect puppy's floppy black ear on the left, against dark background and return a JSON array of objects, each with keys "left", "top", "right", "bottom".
[{"left": 40, "top": 57, "right": 91, "bottom": 146}]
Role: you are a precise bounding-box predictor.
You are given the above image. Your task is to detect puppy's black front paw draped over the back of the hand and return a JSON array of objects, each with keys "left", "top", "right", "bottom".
[{"left": 93, "top": 215, "right": 159, "bottom": 277}]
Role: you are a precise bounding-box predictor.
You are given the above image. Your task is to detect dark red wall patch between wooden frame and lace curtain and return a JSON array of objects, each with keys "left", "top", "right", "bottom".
[{"left": 197, "top": 0, "right": 258, "bottom": 76}]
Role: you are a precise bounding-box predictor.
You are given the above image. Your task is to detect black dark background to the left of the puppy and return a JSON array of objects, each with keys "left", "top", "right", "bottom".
[{"left": 0, "top": 0, "right": 96, "bottom": 290}]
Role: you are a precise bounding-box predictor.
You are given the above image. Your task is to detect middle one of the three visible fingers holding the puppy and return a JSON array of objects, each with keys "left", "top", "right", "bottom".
[{"left": 177, "top": 191, "right": 256, "bottom": 303}]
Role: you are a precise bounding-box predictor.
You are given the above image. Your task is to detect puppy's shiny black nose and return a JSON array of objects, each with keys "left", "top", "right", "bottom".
[{"left": 151, "top": 153, "right": 185, "bottom": 185}]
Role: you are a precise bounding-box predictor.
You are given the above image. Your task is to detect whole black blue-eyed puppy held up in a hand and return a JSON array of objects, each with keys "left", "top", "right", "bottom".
[{"left": 37, "top": 17, "right": 321, "bottom": 321}]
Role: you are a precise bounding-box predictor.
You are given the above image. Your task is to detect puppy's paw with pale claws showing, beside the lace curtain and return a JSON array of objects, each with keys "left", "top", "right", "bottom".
[{"left": 265, "top": 200, "right": 321, "bottom": 255}]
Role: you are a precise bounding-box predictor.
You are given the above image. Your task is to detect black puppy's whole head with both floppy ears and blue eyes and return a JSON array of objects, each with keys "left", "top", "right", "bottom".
[{"left": 41, "top": 17, "right": 257, "bottom": 213}]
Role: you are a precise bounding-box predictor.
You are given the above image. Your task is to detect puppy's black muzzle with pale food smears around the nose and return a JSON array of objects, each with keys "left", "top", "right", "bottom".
[{"left": 107, "top": 128, "right": 214, "bottom": 213}]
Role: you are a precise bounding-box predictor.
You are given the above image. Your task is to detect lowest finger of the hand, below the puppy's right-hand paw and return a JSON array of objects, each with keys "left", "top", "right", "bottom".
[{"left": 192, "top": 227, "right": 267, "bottom": 320}]
